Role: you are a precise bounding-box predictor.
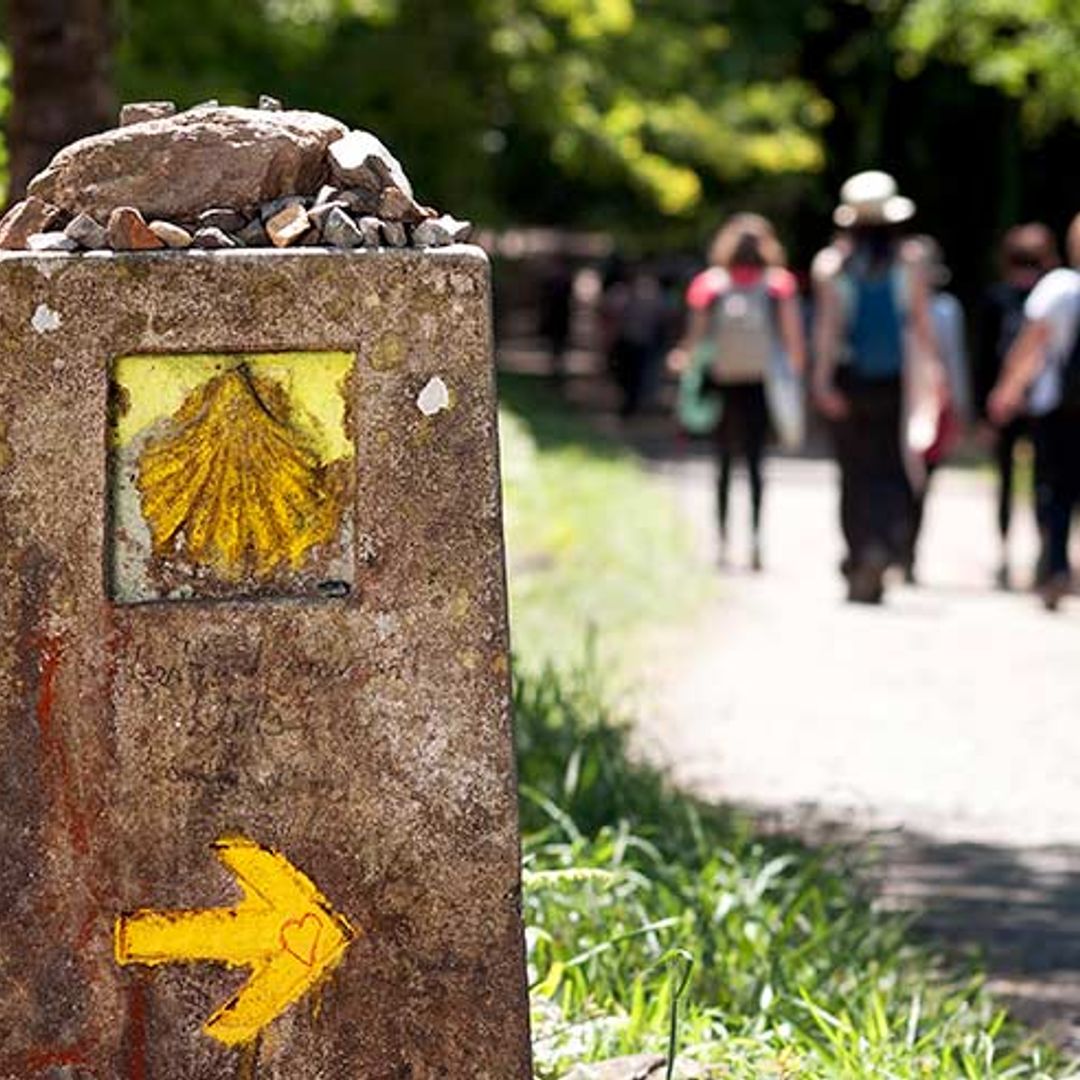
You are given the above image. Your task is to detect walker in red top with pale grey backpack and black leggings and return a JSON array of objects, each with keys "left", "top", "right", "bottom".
[{"left": 669, "top": 214, "right": 806, "bottom": 570}]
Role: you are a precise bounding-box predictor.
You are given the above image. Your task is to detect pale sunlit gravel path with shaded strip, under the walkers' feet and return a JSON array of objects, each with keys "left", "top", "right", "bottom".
[{"left": 640, "top": 453, "right": 1080, "bottom": 1048}]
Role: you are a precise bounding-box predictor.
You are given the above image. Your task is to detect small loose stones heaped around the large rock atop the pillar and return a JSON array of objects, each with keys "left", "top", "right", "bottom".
[{"left": 0, "top": 96, "right": 472, "bottom": 254}]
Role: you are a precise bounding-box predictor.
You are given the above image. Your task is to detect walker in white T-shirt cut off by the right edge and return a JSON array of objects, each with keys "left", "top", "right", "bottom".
[{"left": 988, "top": 214, "right": 1080, "bottom": 611}]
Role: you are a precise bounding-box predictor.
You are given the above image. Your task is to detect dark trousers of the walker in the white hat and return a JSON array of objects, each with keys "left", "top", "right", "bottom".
[{"left": 835, "top": 378, "right": 915, "bottom": 567}]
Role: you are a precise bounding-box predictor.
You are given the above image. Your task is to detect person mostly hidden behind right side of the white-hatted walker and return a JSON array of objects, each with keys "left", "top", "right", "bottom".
[{"left": 904, "top": 235, "right": 971, "bottom": 584}]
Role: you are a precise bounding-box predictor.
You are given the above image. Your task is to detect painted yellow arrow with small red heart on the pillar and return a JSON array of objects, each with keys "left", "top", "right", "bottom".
[{"left": 116, "top": 837, "right": 356, "bottom": 1047}]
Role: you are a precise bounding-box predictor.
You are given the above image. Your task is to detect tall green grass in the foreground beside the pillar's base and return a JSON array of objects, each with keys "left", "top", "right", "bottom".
[{"left": 515, "top": 670, "right": 1072, "bottom": 1080}]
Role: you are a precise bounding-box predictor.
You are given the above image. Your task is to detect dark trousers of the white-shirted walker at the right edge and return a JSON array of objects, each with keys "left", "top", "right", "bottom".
[{"left": 1035, "top": 408, "right": 1080, "bottom": 577}]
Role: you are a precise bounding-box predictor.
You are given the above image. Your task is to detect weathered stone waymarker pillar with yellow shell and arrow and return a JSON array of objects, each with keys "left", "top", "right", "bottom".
[{"left": 0, "top": 247, "right": 530, "bottom": 1080}]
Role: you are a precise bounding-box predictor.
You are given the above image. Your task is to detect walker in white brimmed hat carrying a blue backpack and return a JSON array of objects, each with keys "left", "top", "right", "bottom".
[{"left": 812, "top": 172, "right": 947, "bottom": 604}]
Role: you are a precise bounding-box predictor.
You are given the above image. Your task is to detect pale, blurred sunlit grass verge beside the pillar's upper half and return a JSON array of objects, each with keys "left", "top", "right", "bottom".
[{"left": 500, "top": 376, "right": 715, "bottom": 667}]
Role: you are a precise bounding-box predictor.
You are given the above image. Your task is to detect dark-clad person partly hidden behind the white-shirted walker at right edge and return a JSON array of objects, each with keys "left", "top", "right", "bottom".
[{"left": 973, "top": 222, "right": 1061, "bottom": 589}]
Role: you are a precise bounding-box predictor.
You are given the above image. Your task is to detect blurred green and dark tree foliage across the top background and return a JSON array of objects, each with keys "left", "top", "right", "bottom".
[{"left": 0, "top": 0, "right": 1080, "bottom": 285}]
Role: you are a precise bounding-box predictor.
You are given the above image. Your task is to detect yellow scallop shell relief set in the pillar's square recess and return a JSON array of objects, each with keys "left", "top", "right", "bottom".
[{"left": 137, "top": 365, "right": 343, "bottom": 581}]
